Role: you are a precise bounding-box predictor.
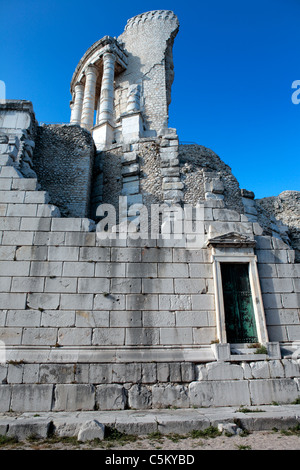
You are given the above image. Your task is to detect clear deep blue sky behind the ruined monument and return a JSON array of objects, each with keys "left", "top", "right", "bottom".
[{"left": 0, "top": 0, "right": 300, "bottom": 198}]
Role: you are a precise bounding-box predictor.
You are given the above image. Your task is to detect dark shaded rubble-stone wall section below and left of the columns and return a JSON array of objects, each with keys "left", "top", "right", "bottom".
[{"left": 32, "top": 124, "right": 95, "bottom": 217}]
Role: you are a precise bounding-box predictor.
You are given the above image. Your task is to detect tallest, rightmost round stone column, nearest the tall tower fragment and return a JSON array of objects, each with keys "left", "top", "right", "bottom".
[{"left": 98, "top": 52, "right": 116, "bottom": 124}]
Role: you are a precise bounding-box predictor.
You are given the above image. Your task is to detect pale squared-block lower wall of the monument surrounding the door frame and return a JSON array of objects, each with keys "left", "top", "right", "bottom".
[{"left": 0, "top": 101, "right": 300, "bottom": 412}]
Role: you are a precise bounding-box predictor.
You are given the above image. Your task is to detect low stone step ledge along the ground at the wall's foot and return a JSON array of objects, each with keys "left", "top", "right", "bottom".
[{"left": 0, "top": 405, "right": 300, "bottom": 440}]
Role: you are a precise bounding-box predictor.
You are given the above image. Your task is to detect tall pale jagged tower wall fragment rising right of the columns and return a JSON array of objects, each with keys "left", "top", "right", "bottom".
[{"left": 116, "top": 11, "right": 179, "bottom": 135}]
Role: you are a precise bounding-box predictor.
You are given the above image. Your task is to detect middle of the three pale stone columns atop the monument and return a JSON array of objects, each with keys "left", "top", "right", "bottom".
[{"left": 81, "top": 65, "right": 98, "bottom": 130}]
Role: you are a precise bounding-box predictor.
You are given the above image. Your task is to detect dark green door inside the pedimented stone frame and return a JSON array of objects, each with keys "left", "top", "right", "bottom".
[{"left": 221, "top": 263, "right": 258, "bottom": 343}]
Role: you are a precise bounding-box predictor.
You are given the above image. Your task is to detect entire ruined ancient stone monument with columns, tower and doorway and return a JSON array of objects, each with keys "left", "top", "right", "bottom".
[{"left": 0, "top": 11, "right": 300, "bottom": 412}]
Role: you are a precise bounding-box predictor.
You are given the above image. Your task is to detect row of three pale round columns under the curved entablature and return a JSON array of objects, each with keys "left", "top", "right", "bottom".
[{"left": 70, "top": 52, "right": 116, "bottom": 130}]
